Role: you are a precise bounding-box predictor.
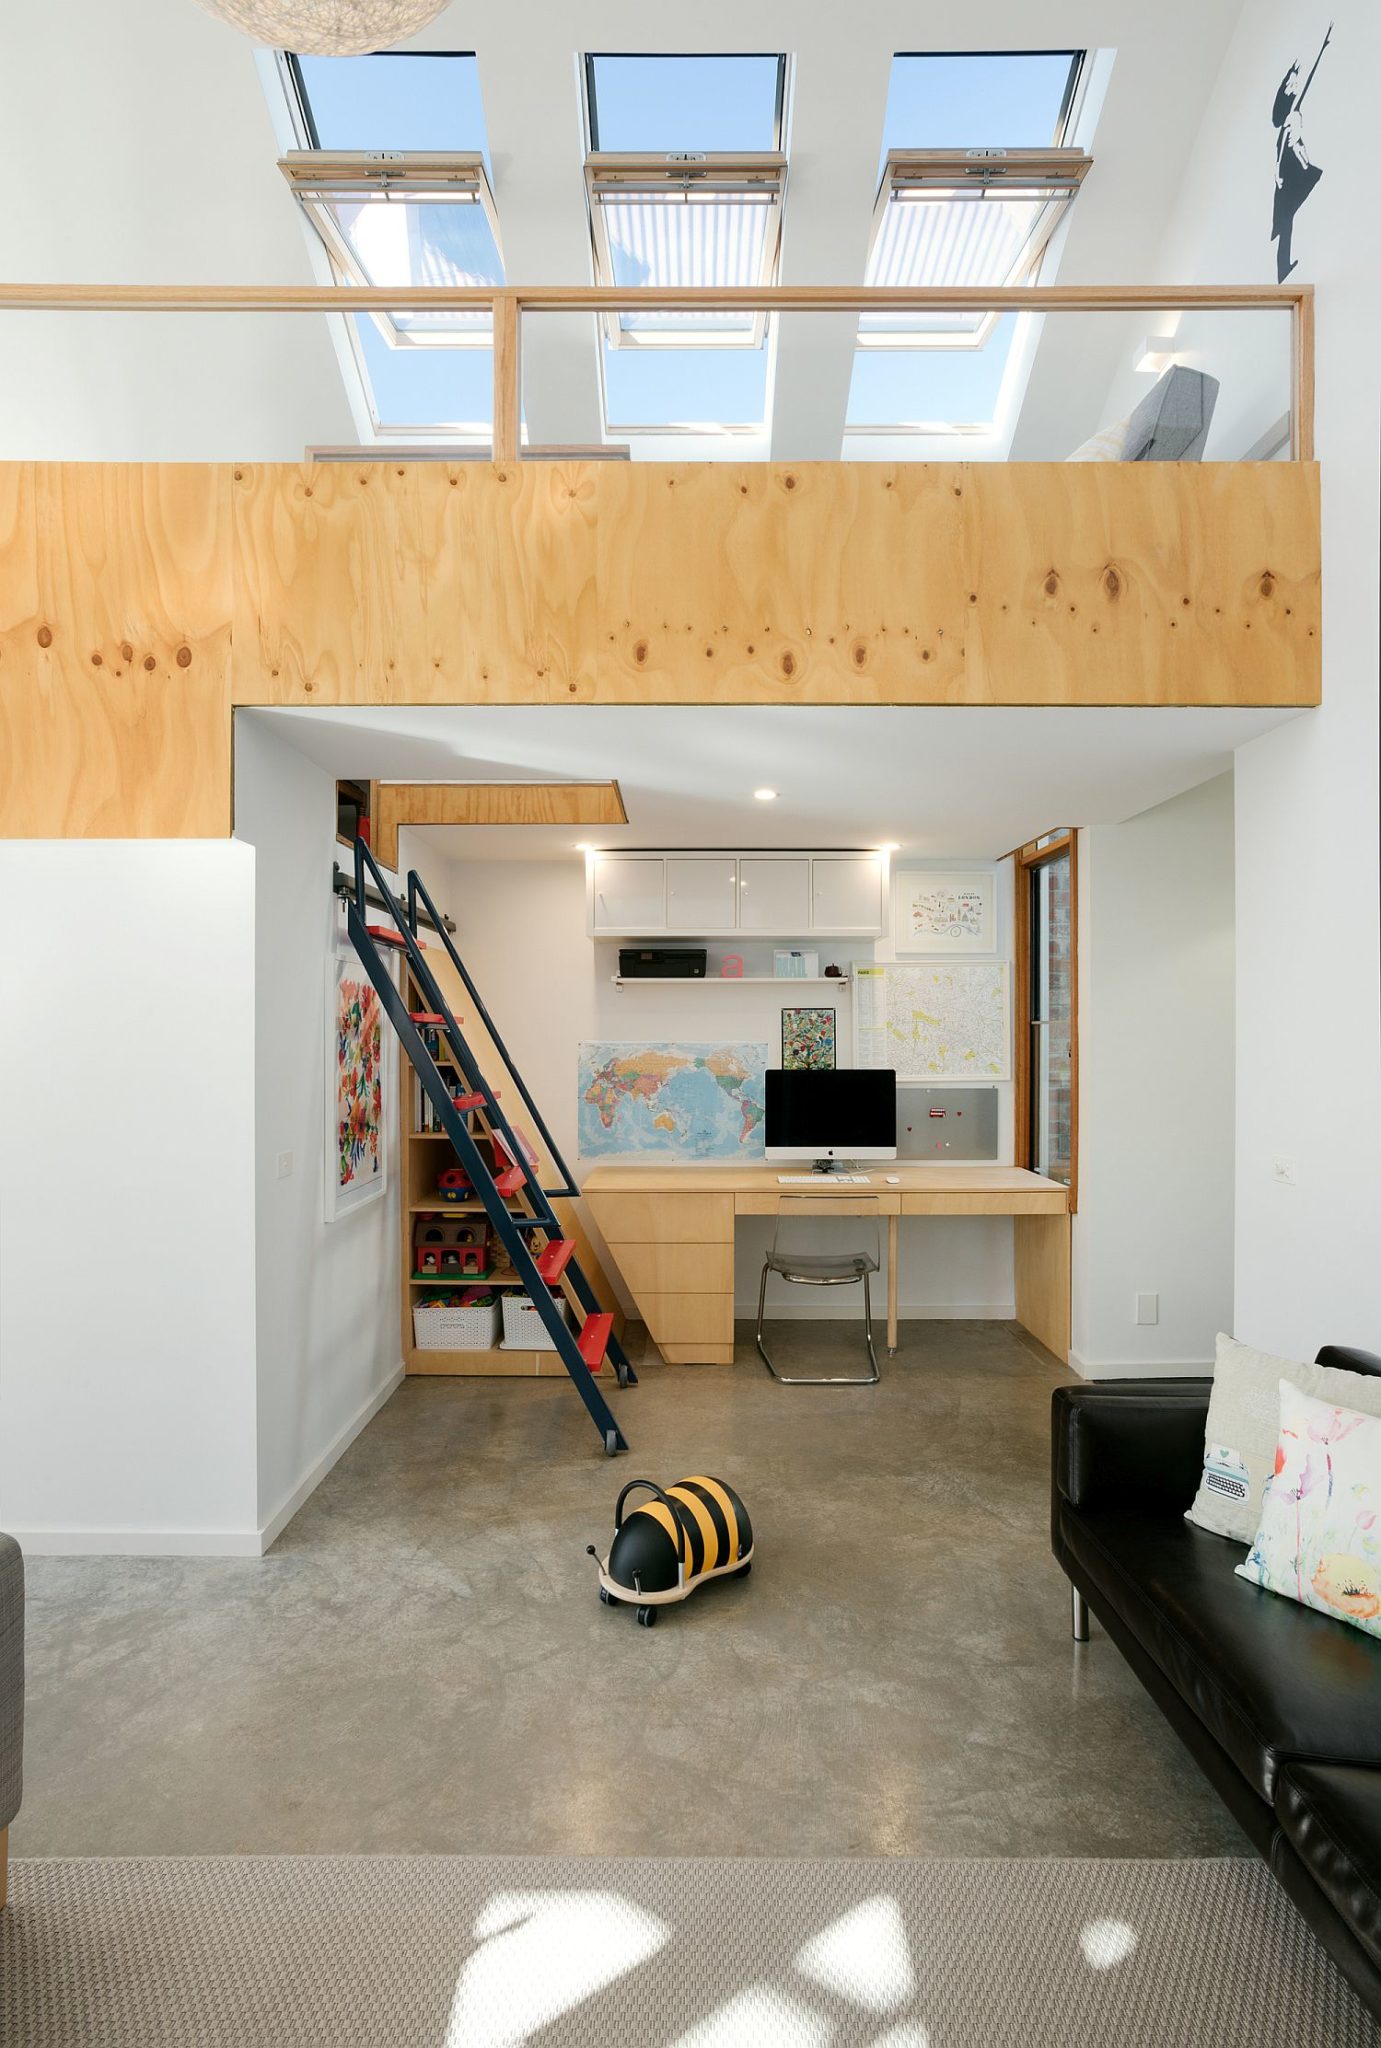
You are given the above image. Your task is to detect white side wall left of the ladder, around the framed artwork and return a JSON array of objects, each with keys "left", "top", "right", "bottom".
[{"left": 236, "top": 713, "right": 402, "bottom": 1540}]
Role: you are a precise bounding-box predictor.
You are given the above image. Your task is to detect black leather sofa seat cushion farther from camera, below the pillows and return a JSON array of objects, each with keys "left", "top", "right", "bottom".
[{"left": 1059, "top": 1509, "right": 1381, "bottom": 1800}]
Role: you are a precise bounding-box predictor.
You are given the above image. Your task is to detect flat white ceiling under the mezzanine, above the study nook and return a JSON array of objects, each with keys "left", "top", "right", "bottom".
[{"left": 247, "top": 705, "right": 1299, "bottom": 860}]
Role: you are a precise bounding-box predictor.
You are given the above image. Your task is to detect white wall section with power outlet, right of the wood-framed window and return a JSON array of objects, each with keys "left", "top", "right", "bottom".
[{"left": 1072, "top": 776, "right": 1233, "bottom": 1376}]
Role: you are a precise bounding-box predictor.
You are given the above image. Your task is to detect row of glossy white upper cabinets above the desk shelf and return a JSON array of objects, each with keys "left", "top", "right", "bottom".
[{"left": 586, "top": 850, "right": 887, "bottom": 938}]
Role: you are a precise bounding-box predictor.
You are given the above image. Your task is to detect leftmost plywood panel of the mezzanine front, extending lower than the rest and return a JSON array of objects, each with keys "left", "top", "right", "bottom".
[{"left": 0, "top": 463, "right": 232, "bottom": 840}]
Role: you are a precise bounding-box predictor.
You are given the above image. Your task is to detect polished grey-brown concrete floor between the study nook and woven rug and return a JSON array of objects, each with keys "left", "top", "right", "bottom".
[{"left": 12, "top": 1323, "right": 1246, "bottom": 1855}]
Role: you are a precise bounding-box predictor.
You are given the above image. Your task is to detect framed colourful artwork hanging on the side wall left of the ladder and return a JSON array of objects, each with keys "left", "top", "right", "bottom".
[{"left": 326, "top": 952, "right": 389, "bottom": 1223}]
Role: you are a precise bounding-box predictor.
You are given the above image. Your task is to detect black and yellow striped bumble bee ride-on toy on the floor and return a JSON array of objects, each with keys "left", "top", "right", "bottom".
[{"left": 586, "top": 1477, "right": 752, "bottom": 1628}]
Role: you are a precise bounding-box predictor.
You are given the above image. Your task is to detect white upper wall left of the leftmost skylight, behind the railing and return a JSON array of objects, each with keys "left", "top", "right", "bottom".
[{"left": 0, "top": 0, "right": 354, "bottom": 463}]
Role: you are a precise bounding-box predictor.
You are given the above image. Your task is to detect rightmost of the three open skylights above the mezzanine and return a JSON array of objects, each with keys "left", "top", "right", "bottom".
[{"left": 848, "top": 49, "right": 1090, "bottom": 432}]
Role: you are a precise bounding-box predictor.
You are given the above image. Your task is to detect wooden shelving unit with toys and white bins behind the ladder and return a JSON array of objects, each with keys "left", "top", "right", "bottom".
[{"left": 397, "top": 956, "right": 613, "bottom": 1380}]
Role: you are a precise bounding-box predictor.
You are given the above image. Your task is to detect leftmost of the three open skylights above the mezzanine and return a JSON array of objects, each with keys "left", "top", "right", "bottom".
[{"left": 283, "top": 51, "right": 504, "bottom": 434}]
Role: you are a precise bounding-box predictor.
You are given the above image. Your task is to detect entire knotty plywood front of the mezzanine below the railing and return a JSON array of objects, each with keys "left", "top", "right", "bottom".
[{"left": 0, "top": 461, "right": 1320, "bottom": 838}]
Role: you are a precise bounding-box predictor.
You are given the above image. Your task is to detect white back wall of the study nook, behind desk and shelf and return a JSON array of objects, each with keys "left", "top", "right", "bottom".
[{"left": 424, "top": 856, "right": 1012, "bottom": 1317}]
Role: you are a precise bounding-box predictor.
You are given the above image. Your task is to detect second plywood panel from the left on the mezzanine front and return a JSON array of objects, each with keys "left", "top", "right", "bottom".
[{"left": 232, "top": 463, "right": 594, "bottom": 705}]
